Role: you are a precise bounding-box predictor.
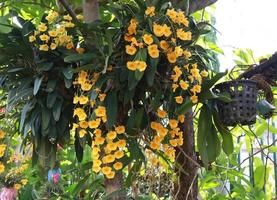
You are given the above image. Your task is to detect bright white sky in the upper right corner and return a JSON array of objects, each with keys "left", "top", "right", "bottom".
[{"left": 214, "top": 0, "right": 277, "bottom": 71}]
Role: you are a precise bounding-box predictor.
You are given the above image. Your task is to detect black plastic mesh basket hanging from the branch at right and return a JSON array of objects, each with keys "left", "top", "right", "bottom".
[{"left": 214, "top": 80, "right": 258, "bottom": 126}]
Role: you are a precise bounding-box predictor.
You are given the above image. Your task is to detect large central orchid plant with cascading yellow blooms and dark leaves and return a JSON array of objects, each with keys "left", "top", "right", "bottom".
[{"left": 69, "top": 1, "right": 232, "bottom": 178}]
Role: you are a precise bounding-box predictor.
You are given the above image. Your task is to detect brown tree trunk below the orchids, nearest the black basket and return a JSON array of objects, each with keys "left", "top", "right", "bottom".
[{"left": 174, "top": 111, "right": 198, "bottom": 200}]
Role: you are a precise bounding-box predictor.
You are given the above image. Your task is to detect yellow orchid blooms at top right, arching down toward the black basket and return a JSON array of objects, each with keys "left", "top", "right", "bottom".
[{"left": 124, "top": 6, "right": 208, "bottom": 104}]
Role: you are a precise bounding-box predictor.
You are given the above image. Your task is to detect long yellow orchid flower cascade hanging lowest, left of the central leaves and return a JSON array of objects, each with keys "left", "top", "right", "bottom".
[{"left": 73, "top": 71, "right": 126, "bottom": 179}]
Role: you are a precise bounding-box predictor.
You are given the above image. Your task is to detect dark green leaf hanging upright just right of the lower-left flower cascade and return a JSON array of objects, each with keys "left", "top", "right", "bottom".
[{"left": 105, "top": 91, "right": 118, "bottom": 128}]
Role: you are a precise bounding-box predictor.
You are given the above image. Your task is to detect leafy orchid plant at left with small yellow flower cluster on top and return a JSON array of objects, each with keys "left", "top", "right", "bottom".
[{"left": 0, "top": 11, "right": 83, "bottom": 166}]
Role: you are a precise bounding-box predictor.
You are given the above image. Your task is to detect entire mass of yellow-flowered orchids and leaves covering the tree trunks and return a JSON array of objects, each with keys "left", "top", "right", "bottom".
[{"left": 1, "top": 0, "right": 239, "bottom": 199}]
